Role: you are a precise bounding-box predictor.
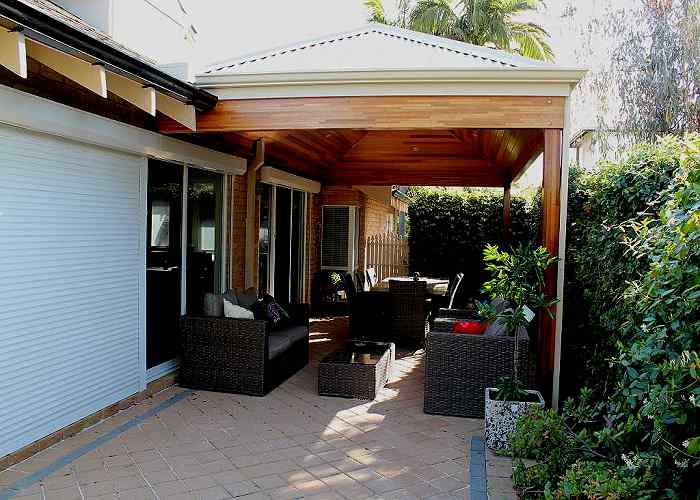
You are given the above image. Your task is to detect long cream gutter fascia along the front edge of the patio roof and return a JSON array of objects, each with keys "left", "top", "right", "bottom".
[{"left": 196, "top": 68, "right": 586, "bottom": 99}]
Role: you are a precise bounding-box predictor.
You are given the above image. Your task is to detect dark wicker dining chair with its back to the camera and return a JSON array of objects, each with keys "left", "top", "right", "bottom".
[{"left": 389, "top": 280, "right": 430, "bottom": 345}]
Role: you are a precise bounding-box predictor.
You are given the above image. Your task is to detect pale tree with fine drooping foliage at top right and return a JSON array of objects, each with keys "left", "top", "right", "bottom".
[{"left": 567, "top": 0, "right": 700, "bottom": 152}]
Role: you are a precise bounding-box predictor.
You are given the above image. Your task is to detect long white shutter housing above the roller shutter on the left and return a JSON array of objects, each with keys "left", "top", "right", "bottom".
[{"left": 0, "top": 85, "right": 247, "bottom": 175}]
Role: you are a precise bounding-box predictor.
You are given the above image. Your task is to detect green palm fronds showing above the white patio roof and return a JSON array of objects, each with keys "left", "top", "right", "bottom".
[{"left": 365, "top": 0, "right": 554, "bottom": 61}]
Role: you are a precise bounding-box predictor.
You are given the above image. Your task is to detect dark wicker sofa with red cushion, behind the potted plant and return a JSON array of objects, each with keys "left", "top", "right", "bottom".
[{"left": 423, "top": 310, "right": 533, "bottom": 418}]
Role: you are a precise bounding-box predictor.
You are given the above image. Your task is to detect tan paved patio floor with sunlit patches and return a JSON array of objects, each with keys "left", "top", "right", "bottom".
[{"left": 0, "top": 318, "right": 512, "bottom": 500}]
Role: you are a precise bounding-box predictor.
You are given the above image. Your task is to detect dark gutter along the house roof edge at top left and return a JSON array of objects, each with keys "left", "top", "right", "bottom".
[{"left": 0, "top": 0, "right": 218, "bottom": 111}]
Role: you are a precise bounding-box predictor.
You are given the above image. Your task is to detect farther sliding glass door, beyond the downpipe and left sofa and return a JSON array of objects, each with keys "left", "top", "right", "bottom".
[{"left": 258, "top": 184, "right": 306, "bottom": 303}]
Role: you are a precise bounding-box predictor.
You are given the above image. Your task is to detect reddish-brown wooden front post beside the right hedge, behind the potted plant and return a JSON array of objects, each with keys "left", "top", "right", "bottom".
[{"left": 537, "top": 129, "right": 562, "bottom": 394}]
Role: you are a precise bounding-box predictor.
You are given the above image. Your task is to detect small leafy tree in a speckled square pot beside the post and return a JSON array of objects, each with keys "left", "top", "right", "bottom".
[{"left": 479, "top": 244, "right": 557, "bottom": 449}]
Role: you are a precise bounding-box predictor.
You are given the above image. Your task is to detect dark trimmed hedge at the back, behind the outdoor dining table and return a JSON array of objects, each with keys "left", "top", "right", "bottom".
[{"left": 408, "top": 189, "right": 540, "bottom": 296}]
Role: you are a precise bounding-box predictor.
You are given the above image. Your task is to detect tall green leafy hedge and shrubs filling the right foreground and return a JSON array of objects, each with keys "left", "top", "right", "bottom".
[{"left": 511, "top": 135, "right": 700, "bottom": 499}]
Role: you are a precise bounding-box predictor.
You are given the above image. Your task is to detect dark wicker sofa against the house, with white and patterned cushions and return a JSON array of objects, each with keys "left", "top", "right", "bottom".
[{"left": 179, "top": 304, "right": 309, "bottom": 396}]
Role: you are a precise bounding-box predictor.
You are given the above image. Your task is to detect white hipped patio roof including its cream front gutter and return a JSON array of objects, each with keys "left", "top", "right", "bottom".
[{"left": 196, "top": 24, "right": 585, "bottom": 99}]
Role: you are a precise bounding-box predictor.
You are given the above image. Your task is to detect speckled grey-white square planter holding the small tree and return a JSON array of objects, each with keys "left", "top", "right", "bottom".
[{"left": 485, "top": 387, "right": 544, "bottom": 450}]
